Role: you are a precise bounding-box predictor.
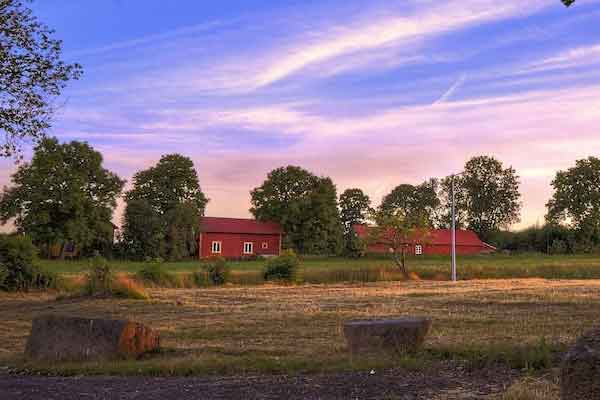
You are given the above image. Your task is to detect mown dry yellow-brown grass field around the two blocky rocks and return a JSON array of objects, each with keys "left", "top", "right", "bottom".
[{"left": 0, "top": 279, "right": 600, "bottom": 375}]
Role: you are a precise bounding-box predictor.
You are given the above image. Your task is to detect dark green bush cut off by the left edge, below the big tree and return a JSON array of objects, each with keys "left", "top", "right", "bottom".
[{"left": 0, "top": 235, "right": 58, "bottom": 291}]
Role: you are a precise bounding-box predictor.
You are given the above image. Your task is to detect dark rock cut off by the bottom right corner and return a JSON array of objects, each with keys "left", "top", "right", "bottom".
[{"left": 560, "top": 329, "right": 600, "bottom": 400}]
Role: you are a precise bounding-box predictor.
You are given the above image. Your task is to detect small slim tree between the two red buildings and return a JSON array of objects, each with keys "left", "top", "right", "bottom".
[{"left": 339, "top": 189, "right": 371, "bottom": 256}]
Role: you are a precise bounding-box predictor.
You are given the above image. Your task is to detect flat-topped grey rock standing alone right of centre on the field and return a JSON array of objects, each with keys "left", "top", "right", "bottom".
[{"left": 344, "top": 317, "right": 431, "bottom": 353}]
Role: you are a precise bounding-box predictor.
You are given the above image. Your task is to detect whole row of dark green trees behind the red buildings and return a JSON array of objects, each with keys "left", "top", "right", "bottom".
[{"left": 0, "top": 138, "right": 600, "bottom": 260}]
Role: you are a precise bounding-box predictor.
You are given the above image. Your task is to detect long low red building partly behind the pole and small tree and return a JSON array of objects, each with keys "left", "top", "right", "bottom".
[{"left": 354, "top": 225, "right": 496, "bottom": 255}]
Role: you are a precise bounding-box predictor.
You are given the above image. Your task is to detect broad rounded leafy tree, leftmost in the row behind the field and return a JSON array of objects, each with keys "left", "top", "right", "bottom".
[{"left": 0, "top": 139, "right": 125, "bottom": 256}]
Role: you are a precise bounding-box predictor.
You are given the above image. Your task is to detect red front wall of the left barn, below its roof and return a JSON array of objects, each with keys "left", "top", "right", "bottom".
[{"left": 199, "top": 233, "right": 280, "bottom": 258}]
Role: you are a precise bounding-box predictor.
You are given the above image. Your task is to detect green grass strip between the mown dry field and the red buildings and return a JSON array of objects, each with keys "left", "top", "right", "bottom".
[{"left": 40, "top": 254, "right": 600, "bottom": 283}]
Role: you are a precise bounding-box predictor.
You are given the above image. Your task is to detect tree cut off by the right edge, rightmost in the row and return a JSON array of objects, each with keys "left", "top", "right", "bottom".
[{"left": 546, "top": 157, "right": 600, "bottom": 244}]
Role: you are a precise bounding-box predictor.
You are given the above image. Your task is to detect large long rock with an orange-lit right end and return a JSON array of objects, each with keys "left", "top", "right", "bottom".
[{"left": 25, "top": 315, "right": 160, "bottom": 361}]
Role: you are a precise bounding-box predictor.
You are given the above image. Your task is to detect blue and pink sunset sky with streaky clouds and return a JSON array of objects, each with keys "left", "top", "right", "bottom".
[{"left": 0, "top": 0, "right": 600, "bottom": 229}]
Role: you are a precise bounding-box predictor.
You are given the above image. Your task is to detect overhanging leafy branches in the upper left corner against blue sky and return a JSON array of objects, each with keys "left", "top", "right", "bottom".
[{"left": 0, "top": 0, "right": 82, "bottom": 156}]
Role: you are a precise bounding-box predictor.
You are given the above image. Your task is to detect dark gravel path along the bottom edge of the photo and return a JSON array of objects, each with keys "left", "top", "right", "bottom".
[{"left": 0, "top": 365, "right": 514, "bottom": 400}]
